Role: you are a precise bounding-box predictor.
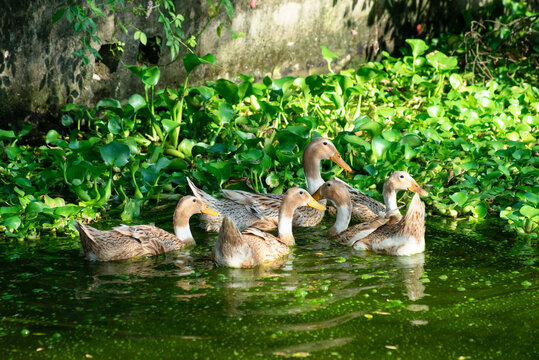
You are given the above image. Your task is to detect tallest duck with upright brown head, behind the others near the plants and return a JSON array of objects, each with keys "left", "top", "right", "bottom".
[{"left": 217, "top": 137, "right": 352, "bottom": 231}]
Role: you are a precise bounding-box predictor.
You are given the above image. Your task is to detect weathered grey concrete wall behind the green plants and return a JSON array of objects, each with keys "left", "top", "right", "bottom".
[{"left": 0, "top": 0, "right": 490, "bottom": 128}]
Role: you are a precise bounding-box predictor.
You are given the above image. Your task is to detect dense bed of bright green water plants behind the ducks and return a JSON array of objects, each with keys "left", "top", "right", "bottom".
[{"left": 0, "top": 2, "right": 539, "bottom": 238}]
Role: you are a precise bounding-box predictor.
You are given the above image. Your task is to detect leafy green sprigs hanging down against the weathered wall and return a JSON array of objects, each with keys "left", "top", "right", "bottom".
[{"left": 52, "top": 0, "right": 234, "bottom": 65}]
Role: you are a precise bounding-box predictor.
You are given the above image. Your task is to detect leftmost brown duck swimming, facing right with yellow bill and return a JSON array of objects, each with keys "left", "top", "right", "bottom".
[{"left": 74, "top": 195, "right": 219, "bottom": 261}]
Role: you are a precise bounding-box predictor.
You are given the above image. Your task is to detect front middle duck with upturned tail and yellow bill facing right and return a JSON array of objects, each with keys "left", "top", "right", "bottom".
[{"left": 212, "top": 187, "right": 326, "bottom": 268}]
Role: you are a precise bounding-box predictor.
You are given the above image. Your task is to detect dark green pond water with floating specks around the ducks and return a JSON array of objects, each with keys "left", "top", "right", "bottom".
[{"left": 0, "top": 215, "right": 539, "bottom": 359}]
